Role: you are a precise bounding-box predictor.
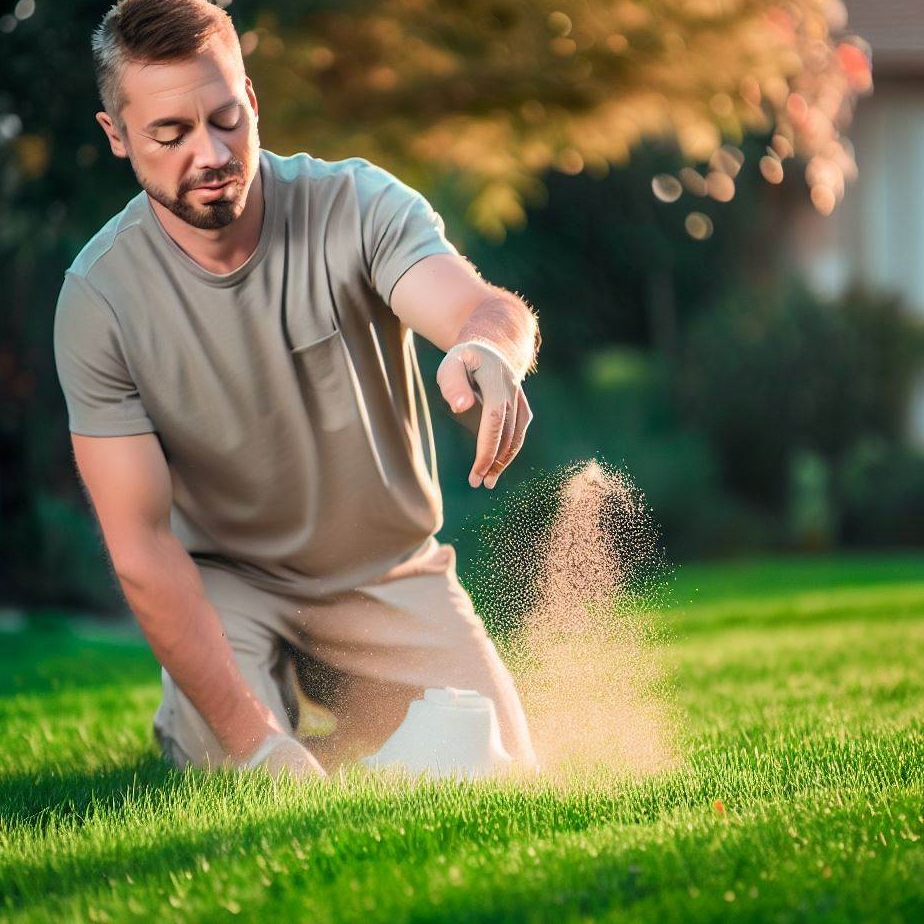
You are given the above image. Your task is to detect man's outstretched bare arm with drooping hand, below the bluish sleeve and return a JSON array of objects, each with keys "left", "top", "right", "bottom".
[{"left": 390, "top": 254, "right": 540, "bottom": 488}]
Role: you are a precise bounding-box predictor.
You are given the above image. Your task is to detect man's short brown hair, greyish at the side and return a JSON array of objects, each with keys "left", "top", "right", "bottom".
[{"left": 92, "top": 0, "right": 243, "bottom": 123}]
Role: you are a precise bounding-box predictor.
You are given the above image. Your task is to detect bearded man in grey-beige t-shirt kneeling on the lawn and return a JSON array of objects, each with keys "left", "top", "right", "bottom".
[{"left": 54, "top": 0, "right": 538, "bottom": 776}]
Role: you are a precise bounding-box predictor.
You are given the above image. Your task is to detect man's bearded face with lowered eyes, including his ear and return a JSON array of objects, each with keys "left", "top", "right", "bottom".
[{"left": 97, "top": 38, "right": 260, "bottom": 229}]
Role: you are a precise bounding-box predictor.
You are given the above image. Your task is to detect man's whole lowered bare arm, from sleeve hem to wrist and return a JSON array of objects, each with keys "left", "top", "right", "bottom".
[{"left": 71, "top": 433, "right": 323, "bottom": 773}]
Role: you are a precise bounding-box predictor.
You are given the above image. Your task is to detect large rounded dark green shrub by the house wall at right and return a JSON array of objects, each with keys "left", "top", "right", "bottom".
[{"left": 676, "top": 282, "right": 924, "bottom": 509}]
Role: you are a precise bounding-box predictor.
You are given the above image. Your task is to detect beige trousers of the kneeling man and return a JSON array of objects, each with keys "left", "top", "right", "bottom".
[{"left": 154, "top": 539, "right": 535, "bottom": 770}]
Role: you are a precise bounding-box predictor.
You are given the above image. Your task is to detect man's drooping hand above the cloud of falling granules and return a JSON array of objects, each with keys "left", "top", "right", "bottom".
[{"left": 436, "top": 341, "right": 533, "bottom": 488}]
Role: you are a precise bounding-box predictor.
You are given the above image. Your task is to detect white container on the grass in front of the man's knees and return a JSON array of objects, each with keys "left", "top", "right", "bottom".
[{"left": 360, "top": 687, "right": 513, "bottom": 779}]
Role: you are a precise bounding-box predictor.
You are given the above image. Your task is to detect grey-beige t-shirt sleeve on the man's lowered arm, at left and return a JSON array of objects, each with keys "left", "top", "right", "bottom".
[{"left": 54, "top": 273, "right": 156, "bottom": 436}]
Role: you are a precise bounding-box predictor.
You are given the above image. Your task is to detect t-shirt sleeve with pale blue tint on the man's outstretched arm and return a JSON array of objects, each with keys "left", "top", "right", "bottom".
[{"left": 356, "top": 161, "right": 459, "bottom": 306}]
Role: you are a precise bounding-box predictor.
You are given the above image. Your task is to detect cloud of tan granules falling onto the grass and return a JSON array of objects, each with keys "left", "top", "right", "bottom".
[{"left": 474, "top": 461, "right": 676, "bottom": 778}]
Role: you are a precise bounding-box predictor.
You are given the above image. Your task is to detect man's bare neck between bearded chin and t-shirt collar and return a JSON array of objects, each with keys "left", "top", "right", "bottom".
[{"left": 148, "top": 161, "right": 265, "bottom": 274}]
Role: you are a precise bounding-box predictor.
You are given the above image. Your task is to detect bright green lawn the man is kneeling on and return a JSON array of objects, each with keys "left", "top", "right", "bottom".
[{"left": 0, "top": 554, "right": 924, "bottom": 924}]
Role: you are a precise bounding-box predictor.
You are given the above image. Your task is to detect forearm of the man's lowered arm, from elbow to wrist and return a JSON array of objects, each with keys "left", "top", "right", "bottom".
[{"left": 117, "top": 532, "right": 288, "bottom": 759}]
